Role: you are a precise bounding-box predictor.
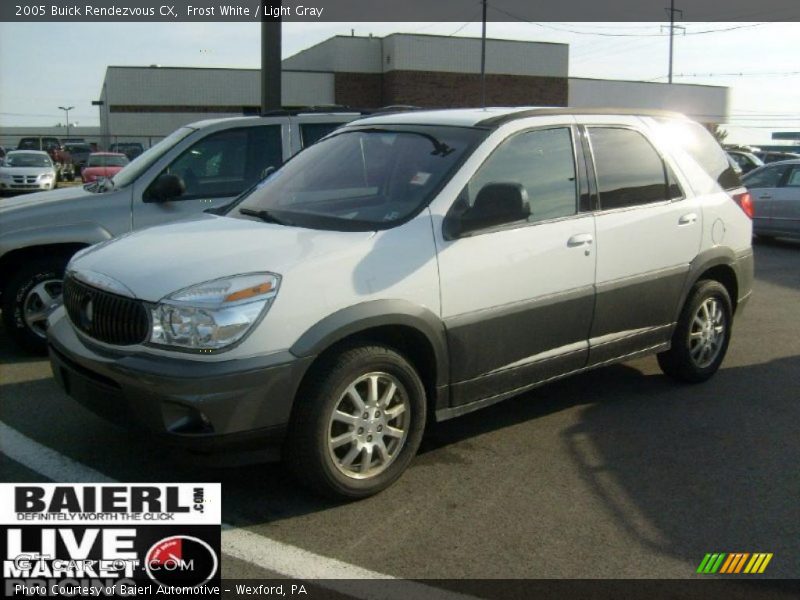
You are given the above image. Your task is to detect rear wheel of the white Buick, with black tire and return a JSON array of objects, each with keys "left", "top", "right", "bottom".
[{"left": 658, "top": 280, "right": 733, "bottom": 383}]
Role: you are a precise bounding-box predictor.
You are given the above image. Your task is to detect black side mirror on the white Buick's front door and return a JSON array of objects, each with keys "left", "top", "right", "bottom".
[{"left": 450, "top": 183, "right": 531, "bottom": 237}]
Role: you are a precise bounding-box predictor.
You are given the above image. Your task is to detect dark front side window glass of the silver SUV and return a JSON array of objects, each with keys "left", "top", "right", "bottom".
[{"left": 164, "top": 125, "right": 283, "bottom": 200}]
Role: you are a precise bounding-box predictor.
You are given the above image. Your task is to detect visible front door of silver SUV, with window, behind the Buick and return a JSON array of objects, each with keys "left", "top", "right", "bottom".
[{"left": 133, "top": 118, "right": 291, "bottom": 229}]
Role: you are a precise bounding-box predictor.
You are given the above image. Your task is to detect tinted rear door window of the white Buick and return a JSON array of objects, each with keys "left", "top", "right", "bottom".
[{"left": 589, "top": 127, "right": 682, "bottom": 210}]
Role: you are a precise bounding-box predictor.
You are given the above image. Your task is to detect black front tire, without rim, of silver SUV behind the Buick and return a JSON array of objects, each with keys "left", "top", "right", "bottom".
[{"left": 2, "top": 256, "right": 69, "bottom": 354}]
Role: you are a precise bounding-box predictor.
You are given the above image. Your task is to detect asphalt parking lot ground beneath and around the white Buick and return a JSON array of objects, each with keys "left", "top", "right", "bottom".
[{"left": 0, "top": 242, "right": 800, "bottom": 579}]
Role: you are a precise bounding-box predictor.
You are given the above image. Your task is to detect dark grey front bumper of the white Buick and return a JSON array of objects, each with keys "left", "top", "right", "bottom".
[{"left": 48, "top": 311, "right": 313, "bottom": 459}]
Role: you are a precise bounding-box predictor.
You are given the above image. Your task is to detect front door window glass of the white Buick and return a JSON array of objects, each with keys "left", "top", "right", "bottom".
[{"left": 467, "top": 127, "right": 577, "bottom": 222}]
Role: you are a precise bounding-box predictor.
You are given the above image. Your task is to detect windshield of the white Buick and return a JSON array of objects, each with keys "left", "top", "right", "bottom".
[{"left": 228, "top": 126, "right": 486, "bottom": 231}]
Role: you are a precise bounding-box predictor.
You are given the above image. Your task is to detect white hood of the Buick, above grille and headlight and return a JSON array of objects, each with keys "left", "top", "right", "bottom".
[{"left": 69, "top": 215, "right": 374, "bottom": 302}]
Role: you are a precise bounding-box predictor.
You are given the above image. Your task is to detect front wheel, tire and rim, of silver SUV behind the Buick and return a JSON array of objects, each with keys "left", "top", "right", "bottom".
[{"left": 2, "top": 257, "right": 68, "bottom": 354}]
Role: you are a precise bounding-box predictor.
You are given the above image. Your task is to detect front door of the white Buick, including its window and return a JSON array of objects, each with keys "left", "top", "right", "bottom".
[{"left": 437, "top": 126, "right": 595, "bottom": 405}]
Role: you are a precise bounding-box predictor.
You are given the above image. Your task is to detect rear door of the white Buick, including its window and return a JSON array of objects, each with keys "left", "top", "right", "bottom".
[{"left": 585, "top": 117, "right": 702, "bottom": 365}]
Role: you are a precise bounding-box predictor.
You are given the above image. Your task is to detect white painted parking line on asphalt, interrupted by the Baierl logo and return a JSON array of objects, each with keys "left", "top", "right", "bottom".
[{"left": 0, "top": 421, "right": 475, "bottom": 600}]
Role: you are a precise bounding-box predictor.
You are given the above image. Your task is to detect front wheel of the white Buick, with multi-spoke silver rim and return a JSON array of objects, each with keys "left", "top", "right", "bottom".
[{"left": 284, "top": 346, "right": 426, "bottom": 499}]
